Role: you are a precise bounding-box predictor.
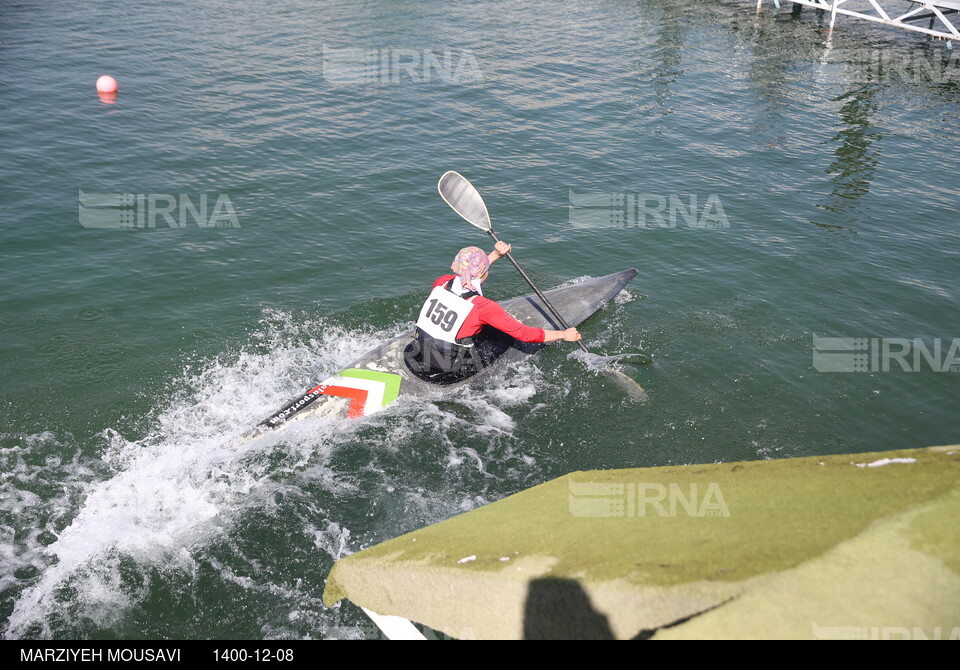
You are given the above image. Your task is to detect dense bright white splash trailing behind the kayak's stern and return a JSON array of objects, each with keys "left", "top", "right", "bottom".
[{"left": 4, "top": 313, "right": 393, "bottom": 638}]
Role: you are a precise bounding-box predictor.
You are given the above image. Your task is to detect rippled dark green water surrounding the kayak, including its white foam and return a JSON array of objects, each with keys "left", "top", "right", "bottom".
[{"left": 0, "top": 0, "right": 960, "bottom": 638}]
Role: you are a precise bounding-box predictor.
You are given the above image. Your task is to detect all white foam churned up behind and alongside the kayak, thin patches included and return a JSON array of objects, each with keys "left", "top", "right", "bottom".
[{"left": 0, "top": 312, "right": 556, "bottom": 638}]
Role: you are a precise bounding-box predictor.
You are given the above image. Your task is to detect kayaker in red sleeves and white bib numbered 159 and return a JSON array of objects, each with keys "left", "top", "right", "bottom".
[{"left": 404, "top": 241, "right": 582, "bottom": 384}]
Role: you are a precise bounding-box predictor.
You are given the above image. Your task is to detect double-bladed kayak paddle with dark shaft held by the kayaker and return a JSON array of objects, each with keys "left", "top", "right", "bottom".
[{"left": 437, "top": 175, "right": 649, "bottom": 400}]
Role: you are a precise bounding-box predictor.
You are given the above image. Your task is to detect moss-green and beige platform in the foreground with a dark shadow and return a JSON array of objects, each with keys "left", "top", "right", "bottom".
[{"left": 324, "top": 447, "right": 960, "bottom": 639}]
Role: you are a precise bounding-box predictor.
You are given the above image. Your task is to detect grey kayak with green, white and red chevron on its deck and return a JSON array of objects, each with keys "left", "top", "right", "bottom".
[{"left": 256, "top": 268, "right": 637, "bottom": 432}]
